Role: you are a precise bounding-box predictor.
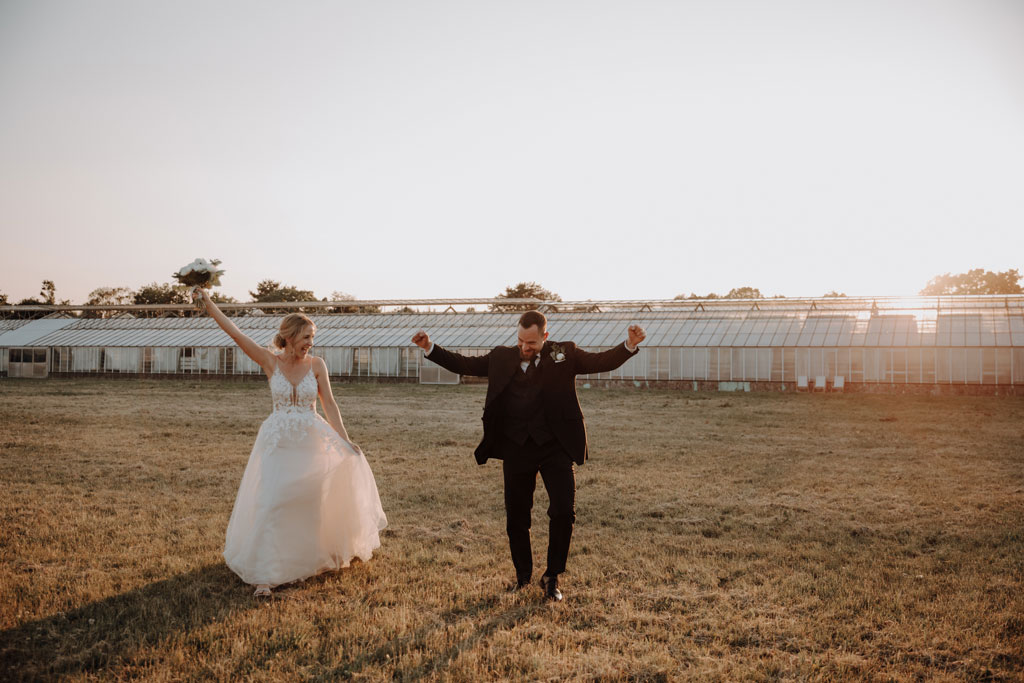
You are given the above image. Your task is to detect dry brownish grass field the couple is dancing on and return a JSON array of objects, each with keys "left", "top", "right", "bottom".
[{"left": 0, "top": 380, "right": 1024, "bottom": 681}]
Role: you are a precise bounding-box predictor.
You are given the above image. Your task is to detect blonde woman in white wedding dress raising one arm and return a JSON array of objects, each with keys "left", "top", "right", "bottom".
[{"left": 199, "top": 289, "right": 387, "bottom": 596}]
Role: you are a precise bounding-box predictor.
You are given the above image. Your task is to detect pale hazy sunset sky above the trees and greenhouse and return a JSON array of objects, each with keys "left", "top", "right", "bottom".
[{"left": 0, "top": 0, "right": 1024, "bottom": 303}]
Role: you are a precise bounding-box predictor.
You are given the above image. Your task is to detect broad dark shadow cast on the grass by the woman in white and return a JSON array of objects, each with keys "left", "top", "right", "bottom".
[{"left": 0, "top": 564, "right": 252, "bottom": 680}]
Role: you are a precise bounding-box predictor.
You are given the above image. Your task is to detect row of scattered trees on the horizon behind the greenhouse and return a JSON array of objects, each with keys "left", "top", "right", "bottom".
[{"left": 0, "top": 268, "right": 1024, "bottom": 317}]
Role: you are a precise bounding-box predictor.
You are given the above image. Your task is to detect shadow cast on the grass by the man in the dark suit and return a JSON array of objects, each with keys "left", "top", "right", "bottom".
[{"left": 329, "top": 596, "right": 551, "bottom": 680}]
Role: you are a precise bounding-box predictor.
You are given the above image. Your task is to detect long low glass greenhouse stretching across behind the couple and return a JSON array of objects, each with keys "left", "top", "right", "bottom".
[{"left": 0, "top": 296, "right": 1024, "bottom": 390}]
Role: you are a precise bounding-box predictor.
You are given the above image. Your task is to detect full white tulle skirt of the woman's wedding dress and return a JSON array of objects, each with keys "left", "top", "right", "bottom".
[{"left": 224, "top": 410, "right": 387, "bottom": 586}]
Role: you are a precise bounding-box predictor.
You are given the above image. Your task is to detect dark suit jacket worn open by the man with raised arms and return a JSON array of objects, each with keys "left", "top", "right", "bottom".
[{"left": 427, "top": 341, "right": 636, "bottom": 465}]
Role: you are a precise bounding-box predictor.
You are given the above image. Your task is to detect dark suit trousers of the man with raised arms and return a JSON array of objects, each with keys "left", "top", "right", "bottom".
[{"left": 502, "top": 437, "right": 575, "bottom": 582}]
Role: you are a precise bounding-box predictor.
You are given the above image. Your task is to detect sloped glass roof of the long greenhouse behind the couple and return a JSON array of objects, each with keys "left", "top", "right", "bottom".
[{"left": 0, "top": 296, "right": 1024, "bottom": 348}]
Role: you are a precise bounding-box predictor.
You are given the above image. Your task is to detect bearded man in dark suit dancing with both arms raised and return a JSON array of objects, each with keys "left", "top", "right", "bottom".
[{"left": 413, "top": 310, "right": 646, "bottom": 601}]
